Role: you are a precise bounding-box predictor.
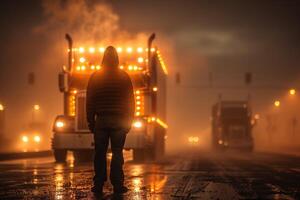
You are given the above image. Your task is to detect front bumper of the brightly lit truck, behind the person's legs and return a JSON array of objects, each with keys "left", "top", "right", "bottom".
[{"left": 52, "top": 132, "right": 146, "bottom": 150}]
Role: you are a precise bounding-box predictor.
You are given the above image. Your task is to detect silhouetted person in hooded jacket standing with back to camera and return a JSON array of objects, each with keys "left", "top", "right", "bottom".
[{"left": 86, "top": 46, "right": 134, "bottom": 194}]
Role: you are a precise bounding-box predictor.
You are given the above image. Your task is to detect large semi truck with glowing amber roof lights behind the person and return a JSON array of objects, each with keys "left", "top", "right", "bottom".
[{"left": 52, "top": 33, "right": 168, "bottom": 162}]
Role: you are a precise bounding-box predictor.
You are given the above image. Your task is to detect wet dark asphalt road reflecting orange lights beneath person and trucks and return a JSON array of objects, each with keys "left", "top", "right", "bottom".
[{"left": 0, "top": 151, "right": 300, "bottom": 200}]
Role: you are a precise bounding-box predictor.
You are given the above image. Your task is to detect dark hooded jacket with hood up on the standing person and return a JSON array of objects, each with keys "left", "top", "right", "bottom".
[{"left": 86, "top": 46, "right": 134, "bottom": 133}]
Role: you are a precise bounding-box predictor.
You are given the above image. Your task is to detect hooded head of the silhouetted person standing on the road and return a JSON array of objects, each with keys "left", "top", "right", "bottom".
[{"left": 102, "top": 46, "right": 119, "bottom": 69}]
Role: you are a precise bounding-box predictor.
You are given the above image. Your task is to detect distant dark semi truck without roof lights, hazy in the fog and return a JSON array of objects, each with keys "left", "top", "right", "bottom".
[{"left": 211, "top": 100, "right": 255, "bottom": 151}]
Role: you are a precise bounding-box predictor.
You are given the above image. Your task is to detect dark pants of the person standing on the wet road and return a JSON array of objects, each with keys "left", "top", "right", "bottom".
[{"left": 94, "top": 128, "right": 126, "bottom": 187}]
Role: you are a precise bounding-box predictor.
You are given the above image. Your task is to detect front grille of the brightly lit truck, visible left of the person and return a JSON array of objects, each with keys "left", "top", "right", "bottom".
[{"left": 76, "top": 92, "right": 88, "bottom": 131}]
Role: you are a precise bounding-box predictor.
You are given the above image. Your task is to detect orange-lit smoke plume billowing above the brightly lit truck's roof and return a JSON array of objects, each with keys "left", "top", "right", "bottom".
[{"left": 34, "top": 0, "right": 146, "bottom": 45}]
